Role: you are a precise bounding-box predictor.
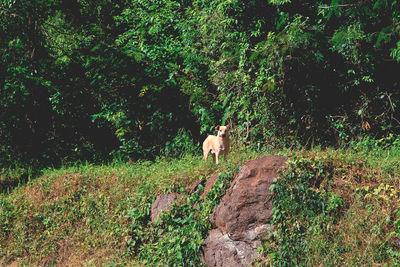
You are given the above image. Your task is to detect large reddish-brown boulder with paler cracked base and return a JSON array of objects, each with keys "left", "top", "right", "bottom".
[{"left": 200, "top": 156, "right": 287, "bottom": 266}]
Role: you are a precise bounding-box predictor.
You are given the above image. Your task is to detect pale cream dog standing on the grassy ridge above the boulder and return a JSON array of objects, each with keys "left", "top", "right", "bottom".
[{"left": 203, "top": 126, "right": 230, "bottom": 164}]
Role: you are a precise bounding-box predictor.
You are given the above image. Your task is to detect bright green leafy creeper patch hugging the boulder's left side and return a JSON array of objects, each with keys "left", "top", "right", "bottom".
[{"left": 128, "top": 170, "right": 238, "bottom": 266}]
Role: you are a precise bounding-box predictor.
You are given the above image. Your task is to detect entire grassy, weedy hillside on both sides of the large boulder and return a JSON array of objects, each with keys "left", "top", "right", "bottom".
[{"left": 0, "top": 139, "right": 400, "bottom": 266}]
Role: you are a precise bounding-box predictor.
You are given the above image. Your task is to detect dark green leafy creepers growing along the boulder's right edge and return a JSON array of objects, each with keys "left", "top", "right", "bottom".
[{"left": 263, "top": 157, "right": 344, "bottom": 266}]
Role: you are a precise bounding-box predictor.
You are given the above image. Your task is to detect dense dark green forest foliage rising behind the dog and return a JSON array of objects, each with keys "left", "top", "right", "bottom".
[{"left": 0, "top": 0, "right": 400, "bottom": 166}]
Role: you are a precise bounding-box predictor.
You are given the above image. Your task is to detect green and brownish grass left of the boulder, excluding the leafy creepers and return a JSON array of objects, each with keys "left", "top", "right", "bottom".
[{"left": 0, "top": 149, "right": 257, "bottom": 265}]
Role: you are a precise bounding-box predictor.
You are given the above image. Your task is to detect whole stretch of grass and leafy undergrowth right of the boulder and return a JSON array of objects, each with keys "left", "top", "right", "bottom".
[{"left": 259, "top": 136, "right": 400, "bottom": 266}]
